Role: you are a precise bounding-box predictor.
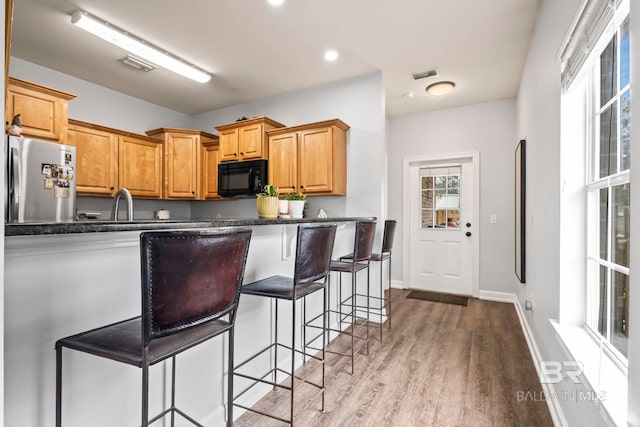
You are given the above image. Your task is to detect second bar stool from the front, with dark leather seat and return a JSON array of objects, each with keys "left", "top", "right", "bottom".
[{"left": 233, "top": 224, "right": 336, "bottom": 426}]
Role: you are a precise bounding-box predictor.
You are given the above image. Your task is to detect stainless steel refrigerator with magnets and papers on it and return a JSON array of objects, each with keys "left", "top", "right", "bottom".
[{"left": 5, "top": 136, "right": 76, "bottom": 222}]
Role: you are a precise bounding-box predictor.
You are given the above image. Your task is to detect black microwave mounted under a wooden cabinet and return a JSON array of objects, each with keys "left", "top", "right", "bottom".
[{"left": 218, "top": 160, "right": 267, "bottom": 197}]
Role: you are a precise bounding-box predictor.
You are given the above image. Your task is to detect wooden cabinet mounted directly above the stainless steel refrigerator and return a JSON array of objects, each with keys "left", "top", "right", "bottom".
[{"left": 5, "top": 77, "right": 75, "bottom": 144}]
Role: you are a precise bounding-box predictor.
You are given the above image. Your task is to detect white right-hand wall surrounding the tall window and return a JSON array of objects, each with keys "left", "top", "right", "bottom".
[{"left": 516, "top": 0, "right": 640, "bottom": 426}]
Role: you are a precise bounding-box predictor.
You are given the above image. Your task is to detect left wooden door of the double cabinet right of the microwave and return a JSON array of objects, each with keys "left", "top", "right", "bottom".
[{"left": 268, "top": 132, "right": 299, "bottom": 194}]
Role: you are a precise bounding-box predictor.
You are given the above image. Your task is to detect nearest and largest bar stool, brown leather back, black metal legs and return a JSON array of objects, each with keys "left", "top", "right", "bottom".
[{"left": 55, "top": 229, "right": 251, "bottom": 427}]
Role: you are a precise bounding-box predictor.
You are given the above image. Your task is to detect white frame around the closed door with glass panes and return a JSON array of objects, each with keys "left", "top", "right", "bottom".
[{"left": 402, "top": 151, "right": 480, "bottom": 298}]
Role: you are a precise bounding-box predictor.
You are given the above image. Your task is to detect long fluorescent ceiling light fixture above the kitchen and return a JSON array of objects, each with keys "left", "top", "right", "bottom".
[{"left": 71, "top": 10, "right": 211, "bottom": 83}]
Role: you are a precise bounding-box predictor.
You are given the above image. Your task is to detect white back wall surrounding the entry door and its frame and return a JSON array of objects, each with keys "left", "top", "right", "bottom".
[{"left": 388, "top": 99, "right": 518, "bottom": 293}]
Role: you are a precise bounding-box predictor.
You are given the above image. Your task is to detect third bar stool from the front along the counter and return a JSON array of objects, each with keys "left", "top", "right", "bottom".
[{"left": 326, "top": 221, "right": 376, "bottom": 375}]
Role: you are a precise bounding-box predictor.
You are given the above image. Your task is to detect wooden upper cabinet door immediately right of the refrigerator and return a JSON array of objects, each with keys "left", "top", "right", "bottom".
[{"left": 68, "top": 125, "right": 118, "bottom": 196}]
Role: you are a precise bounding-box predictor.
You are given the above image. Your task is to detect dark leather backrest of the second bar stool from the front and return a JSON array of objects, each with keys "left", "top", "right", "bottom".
[{"left": 293, "top": 224, "right": 336, "bottom": 285}]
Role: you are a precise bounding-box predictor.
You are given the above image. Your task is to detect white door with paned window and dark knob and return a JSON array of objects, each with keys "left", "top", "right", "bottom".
[{"left": 409, "top": 158, "right": 478, "bottom": 295}]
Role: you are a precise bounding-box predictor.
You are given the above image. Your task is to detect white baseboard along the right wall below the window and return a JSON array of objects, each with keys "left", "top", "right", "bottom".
[{"left": 479, "top": 291, "right": 568, "bottom": 427}]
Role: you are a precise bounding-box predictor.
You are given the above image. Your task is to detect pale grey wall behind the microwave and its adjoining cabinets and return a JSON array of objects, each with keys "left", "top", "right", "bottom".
[{"left": 191, "top": 73, "right": 385, "bottom": 237}]
